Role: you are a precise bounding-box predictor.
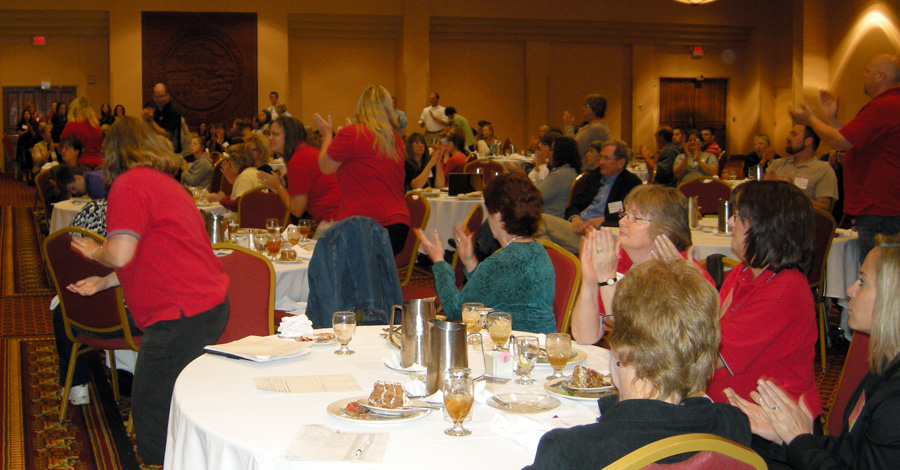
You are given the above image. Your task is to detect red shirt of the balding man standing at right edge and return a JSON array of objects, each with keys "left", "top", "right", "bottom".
[{"left": 840, "top": 87, "right": 900, "bottom": 217}]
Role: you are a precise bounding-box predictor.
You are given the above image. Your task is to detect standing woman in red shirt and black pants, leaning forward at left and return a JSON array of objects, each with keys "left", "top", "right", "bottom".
[{"left": 68, "top": 117, "right": 229, "bottom": 465}]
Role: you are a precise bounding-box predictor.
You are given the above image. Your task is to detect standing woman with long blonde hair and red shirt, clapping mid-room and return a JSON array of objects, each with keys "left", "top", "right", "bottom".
[{"left": 313, "top": 85, "right": 409, "bottom": 254}]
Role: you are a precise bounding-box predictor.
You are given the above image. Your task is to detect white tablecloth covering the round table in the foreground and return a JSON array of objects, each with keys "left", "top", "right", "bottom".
[{"left": 165, "top": 326, "right": 609, "bottom": 470}]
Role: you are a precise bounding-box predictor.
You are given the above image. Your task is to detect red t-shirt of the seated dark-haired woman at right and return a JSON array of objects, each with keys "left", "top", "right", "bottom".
[{"left": 706, "top": 264, "right": 822, "bottom": 416}]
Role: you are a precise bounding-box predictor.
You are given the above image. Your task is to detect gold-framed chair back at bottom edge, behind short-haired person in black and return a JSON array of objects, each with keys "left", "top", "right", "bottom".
[{"left": 604, "top": 433, "right": 768, "bottom": 470}]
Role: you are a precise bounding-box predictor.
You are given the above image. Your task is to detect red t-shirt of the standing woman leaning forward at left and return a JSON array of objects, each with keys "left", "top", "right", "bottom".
[{"left": 106, "top": 167, "right": 228, "bottom": 330}]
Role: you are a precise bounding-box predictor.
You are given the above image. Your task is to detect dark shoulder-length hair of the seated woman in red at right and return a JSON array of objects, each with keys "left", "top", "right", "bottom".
[{"left": 731, "top": 181, "right": 816, "bottom": 274}]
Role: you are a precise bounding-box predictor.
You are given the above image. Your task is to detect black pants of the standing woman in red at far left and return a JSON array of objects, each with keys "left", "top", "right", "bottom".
[{"left": 131, "top": 299, "right": 229, "bottom": 465}]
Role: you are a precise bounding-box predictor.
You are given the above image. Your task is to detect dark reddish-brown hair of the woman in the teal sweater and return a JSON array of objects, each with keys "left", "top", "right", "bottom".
[{"left": 484, "top": 172, "right": 544, "bottom": 237}]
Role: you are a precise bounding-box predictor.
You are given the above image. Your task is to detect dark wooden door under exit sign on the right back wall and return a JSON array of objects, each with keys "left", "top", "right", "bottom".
[{"left": 659, "top": 78, "right": 728, "bottom": 149}]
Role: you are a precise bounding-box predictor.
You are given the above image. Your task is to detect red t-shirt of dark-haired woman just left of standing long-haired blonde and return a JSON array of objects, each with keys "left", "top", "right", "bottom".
[{"left": 287, "top": 142, "right": 341, "bottom": 222}]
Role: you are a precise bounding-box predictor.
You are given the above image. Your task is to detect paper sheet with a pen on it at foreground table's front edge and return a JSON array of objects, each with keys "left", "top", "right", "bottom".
[{"left": 282, "top": 424, "right": 391, "bottom": 463}]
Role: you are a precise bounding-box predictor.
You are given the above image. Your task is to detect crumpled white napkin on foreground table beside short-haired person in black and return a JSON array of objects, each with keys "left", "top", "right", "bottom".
[{"left": 489, "top": 406, "right": 597, "bottom": 453}]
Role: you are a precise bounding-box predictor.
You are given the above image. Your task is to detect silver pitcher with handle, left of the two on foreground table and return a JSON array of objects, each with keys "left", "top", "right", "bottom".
[{"left": 388, "top": 297, "right": 434, "bottom": 367}]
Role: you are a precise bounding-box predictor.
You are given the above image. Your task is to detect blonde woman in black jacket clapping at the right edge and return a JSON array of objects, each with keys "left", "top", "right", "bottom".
[{"left": 725, "top": 235, "right": 900, "bottom": 469}]
